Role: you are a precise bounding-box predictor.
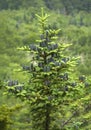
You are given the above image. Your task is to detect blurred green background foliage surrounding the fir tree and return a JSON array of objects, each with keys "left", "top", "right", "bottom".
[{"left": 0, "top": 0, "right": 91, "bottom": 130}]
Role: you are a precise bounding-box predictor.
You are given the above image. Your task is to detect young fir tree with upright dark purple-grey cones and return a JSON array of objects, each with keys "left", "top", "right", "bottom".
[{"left": 6, "top": 10, "right": 86, "bottom": 130}]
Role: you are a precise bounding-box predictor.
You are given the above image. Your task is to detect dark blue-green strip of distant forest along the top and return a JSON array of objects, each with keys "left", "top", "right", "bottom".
[{"left": 0, "top": 0, "right": 91, "bottom": 14}]
